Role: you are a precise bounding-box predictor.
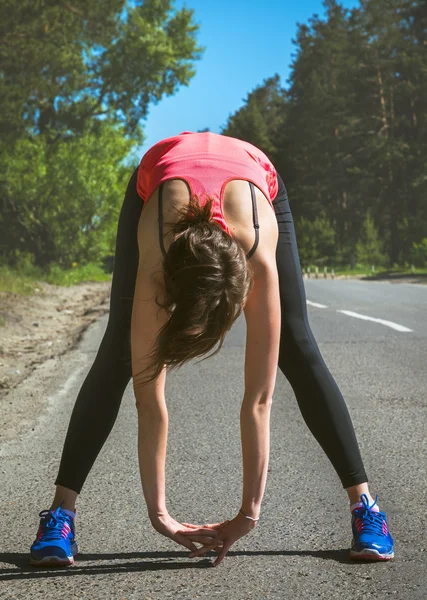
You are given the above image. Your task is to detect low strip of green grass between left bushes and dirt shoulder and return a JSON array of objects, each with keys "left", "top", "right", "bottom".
[{"left": 0, "top": 263, "right": 111, "bottom": 296}]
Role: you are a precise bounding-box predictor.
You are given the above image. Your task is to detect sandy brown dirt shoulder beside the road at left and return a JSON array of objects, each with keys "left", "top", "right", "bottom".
[{"left": 0, "top": 282, "right": 111, "bottom": 406}]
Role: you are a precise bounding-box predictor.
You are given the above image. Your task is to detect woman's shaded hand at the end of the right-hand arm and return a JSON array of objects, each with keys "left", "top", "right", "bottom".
[{"left": 183, "top": 513, "right": 256, "bottom": 567}]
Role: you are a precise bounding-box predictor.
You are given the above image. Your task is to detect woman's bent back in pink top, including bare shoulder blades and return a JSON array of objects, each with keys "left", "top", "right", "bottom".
[{"left": 137, "top": 133, "right": 277, "bottom": 268}]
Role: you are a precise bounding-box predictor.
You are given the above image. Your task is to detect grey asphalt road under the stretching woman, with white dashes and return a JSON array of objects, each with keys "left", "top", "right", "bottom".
[{"left": 0, "top": 280, "right": 427, "bottom": 600}]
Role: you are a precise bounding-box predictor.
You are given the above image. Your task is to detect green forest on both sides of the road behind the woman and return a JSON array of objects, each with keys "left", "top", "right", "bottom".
[{"left": 0, "top": 0, "right": 427, "bottom": 268}]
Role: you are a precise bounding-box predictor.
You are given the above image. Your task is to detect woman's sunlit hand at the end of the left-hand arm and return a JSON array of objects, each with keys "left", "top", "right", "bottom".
[{"left": 151, "top": 513, "right": 221, "bottom": 552}]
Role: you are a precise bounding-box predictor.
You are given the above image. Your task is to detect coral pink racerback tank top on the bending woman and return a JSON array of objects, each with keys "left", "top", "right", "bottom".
[{"left": 137, "top": 131, "right": 278, "bottom": 235}]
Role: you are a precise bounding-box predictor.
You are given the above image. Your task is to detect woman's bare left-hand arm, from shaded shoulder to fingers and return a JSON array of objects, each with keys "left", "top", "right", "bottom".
[{"left": 131, "top": 213, "right": 222, "bottom": 551}]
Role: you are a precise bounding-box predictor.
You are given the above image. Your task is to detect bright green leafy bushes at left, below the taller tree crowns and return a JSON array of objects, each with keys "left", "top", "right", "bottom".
[{"left": 0, "top": 122, "right": 130, "bottom": 267}]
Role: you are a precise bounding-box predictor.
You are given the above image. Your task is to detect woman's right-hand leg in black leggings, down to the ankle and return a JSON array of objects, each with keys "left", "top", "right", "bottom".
[{"left": 273, "top": 171, "right": 370, "bottom": 502}]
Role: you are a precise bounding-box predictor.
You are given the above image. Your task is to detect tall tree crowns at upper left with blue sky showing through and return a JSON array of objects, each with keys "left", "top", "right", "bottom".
[{"left": 0, "top": 0, "right": 201, "bottom": 139}]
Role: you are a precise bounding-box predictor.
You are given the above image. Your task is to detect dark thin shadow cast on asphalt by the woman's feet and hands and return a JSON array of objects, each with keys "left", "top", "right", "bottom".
[{"left": 0, "top": 548, "right": 355, "bottom": 581}]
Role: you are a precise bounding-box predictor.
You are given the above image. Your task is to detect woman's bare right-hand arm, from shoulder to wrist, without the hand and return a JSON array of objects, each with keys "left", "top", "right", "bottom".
[{"left": 240, "top": 257, "right": 281, "bottom": 518}]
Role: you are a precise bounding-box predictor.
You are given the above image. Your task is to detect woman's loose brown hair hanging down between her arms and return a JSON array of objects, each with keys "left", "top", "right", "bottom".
[{"left": 138, "top": 196, "right": 253, "bottom": 384}]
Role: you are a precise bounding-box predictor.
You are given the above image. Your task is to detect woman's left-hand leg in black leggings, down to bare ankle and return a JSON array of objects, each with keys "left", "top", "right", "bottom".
[{"left": 51, "top": 166, "right": 143, "bottom": 510}]
